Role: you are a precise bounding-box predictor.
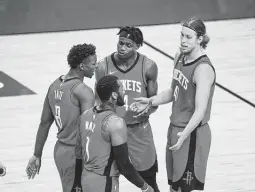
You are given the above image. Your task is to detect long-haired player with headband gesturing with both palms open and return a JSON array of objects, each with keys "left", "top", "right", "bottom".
[{"left": 131, "top": 18, "right": 216, "bottom": 192}]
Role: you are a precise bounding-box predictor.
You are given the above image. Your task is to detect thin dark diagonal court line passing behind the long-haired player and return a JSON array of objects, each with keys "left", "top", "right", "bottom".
[{"left": 143, "top": 40, "right": 255, "bottom": 108}]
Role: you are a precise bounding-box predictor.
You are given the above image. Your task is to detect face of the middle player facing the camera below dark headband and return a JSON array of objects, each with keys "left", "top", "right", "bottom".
[{"left": 117, "top": 37, "right": 137, "bottom": 59}]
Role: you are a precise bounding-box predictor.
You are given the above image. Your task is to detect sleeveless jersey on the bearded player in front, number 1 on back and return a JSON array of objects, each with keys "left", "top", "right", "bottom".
[{"left": 79, "top": 107, "right": 119, "bottom": 176}]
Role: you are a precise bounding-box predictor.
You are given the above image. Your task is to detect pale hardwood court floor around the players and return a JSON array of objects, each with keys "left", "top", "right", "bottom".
[{"left": 0, "top": 19, "right": 255, "bottom": 192}]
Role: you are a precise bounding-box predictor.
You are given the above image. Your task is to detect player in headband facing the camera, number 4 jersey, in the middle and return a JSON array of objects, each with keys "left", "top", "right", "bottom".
[{"left": 96, "top": 26, "right": 159, "bottom": 192}]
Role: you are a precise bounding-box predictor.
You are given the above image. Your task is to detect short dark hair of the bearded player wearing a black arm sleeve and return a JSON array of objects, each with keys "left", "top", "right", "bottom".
[{"left": 96, "top": 75, "right": 120, "bottom": 102}]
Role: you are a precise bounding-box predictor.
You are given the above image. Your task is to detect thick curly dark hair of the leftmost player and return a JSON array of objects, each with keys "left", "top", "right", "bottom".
[{"left": 67, "top": 43, "right": 96, "bottom": 69}]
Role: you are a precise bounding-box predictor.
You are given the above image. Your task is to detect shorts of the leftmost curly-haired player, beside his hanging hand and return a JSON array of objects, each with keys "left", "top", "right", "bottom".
[{"left": 54, "top": 141, "right": 82, "bottom": 192}]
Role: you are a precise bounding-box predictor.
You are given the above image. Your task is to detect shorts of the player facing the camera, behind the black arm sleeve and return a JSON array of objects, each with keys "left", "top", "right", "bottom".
[{"left": 127, "top": 120, "right": 157, "bottom": 171}]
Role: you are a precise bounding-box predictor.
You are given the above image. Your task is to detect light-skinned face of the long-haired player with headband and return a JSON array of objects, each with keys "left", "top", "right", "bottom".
[{"left": 180, "top": 26, "right": 200, "bottom": 54}]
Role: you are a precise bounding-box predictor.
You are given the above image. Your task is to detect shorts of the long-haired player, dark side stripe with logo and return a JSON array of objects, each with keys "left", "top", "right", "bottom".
[{"left": 166, "top": 124, "right": 211, "bottom": 192}]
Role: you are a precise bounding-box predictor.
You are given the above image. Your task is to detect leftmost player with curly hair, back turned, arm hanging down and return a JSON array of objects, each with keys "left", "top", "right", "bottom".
[{"left": 27, "top": 44, "right": 97, "bottom": 192}]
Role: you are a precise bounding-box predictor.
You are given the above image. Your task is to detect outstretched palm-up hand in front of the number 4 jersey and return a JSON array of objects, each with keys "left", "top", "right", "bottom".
[{"left": 130, "top": 97, "right": 150, "bottom": 118}]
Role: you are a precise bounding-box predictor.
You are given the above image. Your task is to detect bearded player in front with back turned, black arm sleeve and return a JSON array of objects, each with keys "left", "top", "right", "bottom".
[{"left": 75, "top": 75, "right": 154, "bottom": 192}]
